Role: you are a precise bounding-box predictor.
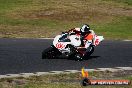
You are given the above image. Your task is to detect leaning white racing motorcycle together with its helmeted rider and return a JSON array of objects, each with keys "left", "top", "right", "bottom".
[{"left": 42, "top": 24, "right": 104, "bottom": 61}]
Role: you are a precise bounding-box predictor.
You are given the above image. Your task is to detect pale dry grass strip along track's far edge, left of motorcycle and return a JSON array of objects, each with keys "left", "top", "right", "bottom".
[{"left": 0, "top": 25, "right": 60, "bottom": 38}]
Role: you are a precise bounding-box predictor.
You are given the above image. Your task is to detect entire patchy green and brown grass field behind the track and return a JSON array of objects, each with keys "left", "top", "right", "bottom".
[{"left": 0, "top": 0, "right": 132, "bottom": 39}]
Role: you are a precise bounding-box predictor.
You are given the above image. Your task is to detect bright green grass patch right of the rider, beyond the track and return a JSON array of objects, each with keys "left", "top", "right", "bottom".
[{"left": 95, "top": 17, "right": 132, "bottom": 39}]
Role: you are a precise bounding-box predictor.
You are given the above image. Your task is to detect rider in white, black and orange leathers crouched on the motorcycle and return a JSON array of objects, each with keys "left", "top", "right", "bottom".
[{"left": 69, "top": 24, "right": 94, "bottom": 48}]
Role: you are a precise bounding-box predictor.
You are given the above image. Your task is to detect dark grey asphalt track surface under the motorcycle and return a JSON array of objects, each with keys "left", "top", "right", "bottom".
[{"left": 0, "top": 39, "right": 132, "bottom": 75}]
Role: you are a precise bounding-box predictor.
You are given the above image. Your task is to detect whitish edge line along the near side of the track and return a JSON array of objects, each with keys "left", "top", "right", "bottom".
[{"left": 0, "top": 67, "right": 132, "bottom": 79}]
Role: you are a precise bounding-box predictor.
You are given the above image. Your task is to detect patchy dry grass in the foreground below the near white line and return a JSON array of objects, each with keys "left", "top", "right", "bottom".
[{"left": 0, "top": 71, "right": 132, "bottom": 88}]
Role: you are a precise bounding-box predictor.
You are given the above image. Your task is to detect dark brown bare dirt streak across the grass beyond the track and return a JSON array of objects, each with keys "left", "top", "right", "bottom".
[{"left": 21, "top": 10, "right": 108, "bottom": 21}]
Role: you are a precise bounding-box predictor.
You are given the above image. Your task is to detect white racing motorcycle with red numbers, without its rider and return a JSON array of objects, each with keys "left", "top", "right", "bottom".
[{"left": 42, "top": 32, "right": 104, "bottom": 61}]
